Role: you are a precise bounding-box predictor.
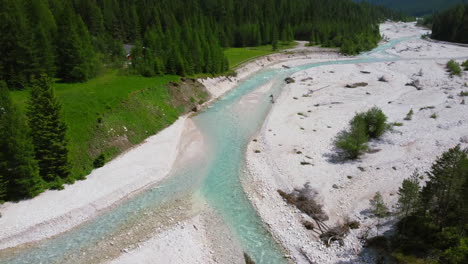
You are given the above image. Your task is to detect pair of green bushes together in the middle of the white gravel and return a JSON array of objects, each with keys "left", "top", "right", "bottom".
[{"left": 334, "top": 107, "right": 388, "bottom": 159}]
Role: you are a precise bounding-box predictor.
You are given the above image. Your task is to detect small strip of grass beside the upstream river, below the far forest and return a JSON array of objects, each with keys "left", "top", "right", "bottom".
[{"left": 224, "top": 42, "right": 297, "bottom": 70}]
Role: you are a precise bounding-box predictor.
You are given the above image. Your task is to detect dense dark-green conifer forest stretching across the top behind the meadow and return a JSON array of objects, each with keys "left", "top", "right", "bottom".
[{"left": 0, "top": 0, "right": 405, "bottom": 89}]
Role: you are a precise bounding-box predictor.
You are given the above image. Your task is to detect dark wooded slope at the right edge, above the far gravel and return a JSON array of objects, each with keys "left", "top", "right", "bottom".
[{"left": 431, "top": 4, "right": 468, "bottom": 43}]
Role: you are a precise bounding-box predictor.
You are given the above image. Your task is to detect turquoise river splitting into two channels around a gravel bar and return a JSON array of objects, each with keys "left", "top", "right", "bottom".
[{"left": 0, "top": 35, "right": 414, "bottom": 264}]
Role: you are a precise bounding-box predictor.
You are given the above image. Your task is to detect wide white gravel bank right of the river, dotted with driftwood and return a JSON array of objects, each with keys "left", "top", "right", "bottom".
[{"left": 243, "top": 23, "right": 468, "bottom": 263}]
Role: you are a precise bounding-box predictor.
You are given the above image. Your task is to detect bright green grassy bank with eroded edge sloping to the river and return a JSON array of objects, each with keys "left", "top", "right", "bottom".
[{"left": 12, "top": 71, "right": 209, "bottom": 181}]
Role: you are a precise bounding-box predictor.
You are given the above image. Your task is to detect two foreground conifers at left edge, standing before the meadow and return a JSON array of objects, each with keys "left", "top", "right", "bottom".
[{"left": 0, "top": 75, "right": 69, "bottom": 200}]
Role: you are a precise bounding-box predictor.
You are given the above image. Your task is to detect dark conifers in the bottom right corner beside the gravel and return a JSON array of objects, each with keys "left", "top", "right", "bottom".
[{"left": 392, "top": 146, "right": 468, "bottom": 264}]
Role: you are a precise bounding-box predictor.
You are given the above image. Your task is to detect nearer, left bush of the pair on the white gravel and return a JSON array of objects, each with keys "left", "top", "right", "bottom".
[{"left": 335, "top": 114, "right": 369, "bottom": 159}]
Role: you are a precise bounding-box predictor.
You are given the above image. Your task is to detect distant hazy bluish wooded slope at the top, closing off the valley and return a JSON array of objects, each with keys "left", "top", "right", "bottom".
[{"left": 356, "top": 0, "right": 467, "bottom": 16}]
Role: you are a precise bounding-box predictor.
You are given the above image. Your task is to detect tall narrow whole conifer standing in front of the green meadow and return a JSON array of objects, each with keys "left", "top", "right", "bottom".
[{"left": 27, "top": 75, "right": 69, "bottom": 188}]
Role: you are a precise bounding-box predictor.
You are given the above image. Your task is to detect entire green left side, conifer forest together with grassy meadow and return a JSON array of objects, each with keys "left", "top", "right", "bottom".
[{"left": 0, "top": 0, "right": 405, "bottom": 201}]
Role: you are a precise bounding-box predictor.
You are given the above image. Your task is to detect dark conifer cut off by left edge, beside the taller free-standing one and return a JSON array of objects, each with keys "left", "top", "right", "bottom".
[{"left": 0, "top": 81, "right": 44, "bottom": 200}]
